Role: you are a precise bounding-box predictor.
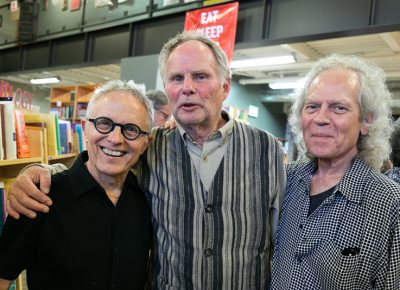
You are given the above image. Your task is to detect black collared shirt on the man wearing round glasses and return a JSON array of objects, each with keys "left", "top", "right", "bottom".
[{"left": 0, "top": 152, "right": 152, "bottom": 290}]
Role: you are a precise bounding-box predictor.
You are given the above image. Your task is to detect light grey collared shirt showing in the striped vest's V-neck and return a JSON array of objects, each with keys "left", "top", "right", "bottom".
[{"left": 177, "top": 111, "right": 233, "bottom": 190}]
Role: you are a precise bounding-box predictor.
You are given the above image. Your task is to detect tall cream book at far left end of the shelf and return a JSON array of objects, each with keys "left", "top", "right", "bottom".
[{"left": 0, "top": 100, "right": 17, "bottom": 160}]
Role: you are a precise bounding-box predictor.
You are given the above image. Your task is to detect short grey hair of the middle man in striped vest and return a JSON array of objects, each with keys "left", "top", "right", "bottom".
[{"left": 158, "top": 31, "right": 232, "bottom": 84}]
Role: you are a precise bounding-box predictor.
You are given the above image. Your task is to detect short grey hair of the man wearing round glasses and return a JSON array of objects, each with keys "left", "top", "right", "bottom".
[{"left": 86, "top": 80, "right": 153, "bottom": 130}]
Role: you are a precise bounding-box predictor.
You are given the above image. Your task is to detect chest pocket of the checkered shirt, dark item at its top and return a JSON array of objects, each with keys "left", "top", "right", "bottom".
[{"left": 313, "top": 240, "right": 360, "bottom": 290}]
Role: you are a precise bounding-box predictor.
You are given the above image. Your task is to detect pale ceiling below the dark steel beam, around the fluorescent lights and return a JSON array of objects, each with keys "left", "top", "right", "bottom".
[{"left": 0, "top": 31, "right": 400, "bottom": 107}]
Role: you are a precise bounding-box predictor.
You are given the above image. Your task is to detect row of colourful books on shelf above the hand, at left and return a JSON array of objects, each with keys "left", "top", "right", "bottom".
[{"left": 0, "top": 98, "right": 85, "bottom": 160}]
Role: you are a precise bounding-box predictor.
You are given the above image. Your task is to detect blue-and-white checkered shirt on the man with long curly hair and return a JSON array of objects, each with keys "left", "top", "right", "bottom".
[{"left": 271, "top": 159, "right": 400, "bottom": 290}]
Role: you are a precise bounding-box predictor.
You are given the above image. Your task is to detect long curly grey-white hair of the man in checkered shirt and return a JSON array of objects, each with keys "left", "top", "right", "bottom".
[{"left": 289, "top": 54, "right": 393, "bottom": 169}]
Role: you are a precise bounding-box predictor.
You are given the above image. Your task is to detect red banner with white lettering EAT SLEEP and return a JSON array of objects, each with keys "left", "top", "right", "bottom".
[{"left": 185, "top": 2, "right": 239, "bottom": 61}]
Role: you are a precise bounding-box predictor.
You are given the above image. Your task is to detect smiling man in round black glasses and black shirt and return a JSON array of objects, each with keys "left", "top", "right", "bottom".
[{"left": 0, "top": 81, "right": 152, "bottom": 290}]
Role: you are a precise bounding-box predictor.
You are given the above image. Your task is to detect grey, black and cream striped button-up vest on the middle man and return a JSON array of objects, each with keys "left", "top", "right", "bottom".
[{"left": 139, "top": 121, "right": 284, "bottom": 290}]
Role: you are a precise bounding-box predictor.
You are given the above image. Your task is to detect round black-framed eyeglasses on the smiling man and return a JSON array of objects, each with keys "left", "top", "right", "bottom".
[{"left": 88, "top": 117, "right": 149, "bottom": 140}]
